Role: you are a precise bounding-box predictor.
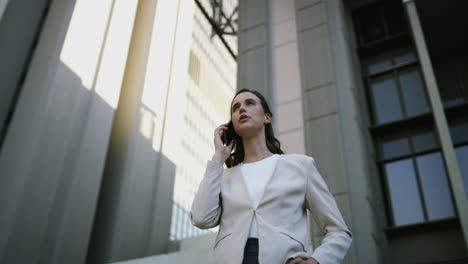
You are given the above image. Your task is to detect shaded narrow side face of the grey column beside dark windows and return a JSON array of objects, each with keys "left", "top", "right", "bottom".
[{"left": 324, "top": 0, "right": 387, "bottom": 263}]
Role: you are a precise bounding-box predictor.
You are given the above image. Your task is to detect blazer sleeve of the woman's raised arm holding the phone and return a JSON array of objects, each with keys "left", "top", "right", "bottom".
[{"left": 190, "top": 160, "right": 224, "bottom": 229}]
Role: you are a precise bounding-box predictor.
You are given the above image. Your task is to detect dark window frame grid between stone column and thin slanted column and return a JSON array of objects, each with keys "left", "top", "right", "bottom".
[{"left": 350, "top": 1, "right": 462, "bottom": 230}]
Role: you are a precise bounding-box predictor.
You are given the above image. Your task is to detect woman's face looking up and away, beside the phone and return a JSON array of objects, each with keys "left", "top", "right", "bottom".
[{"left": 231, "top": 92, "right": 271, "bottom": 137}]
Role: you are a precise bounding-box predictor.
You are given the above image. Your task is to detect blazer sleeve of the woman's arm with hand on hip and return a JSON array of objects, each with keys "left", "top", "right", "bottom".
[{"left": 306, "top": 157, "right": 352, "bottom": 264}]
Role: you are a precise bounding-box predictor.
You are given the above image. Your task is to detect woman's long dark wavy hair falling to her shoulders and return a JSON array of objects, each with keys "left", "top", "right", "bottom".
[{"left": 225, "top": 89, "right": 284, "bottom": 168}]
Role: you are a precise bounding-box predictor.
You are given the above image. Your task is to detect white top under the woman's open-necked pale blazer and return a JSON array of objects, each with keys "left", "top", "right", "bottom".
[{"left": 240, "top": 154, "right": 279, "bottom": 238}]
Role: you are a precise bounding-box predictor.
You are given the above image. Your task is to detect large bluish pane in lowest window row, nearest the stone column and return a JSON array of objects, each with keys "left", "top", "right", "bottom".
[{"left": 385, "top": 159, "right": 424, "bottom": 226}]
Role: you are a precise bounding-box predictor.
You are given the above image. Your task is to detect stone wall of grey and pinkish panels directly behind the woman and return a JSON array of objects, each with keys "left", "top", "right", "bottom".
[{"left": 238, "top": 0, "right": 384, "bottom": 263}]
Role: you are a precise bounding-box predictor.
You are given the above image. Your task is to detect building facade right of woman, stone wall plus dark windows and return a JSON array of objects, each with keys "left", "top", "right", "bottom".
[{"left": 238, "top": 0, "right": 468, "bottom": 263}]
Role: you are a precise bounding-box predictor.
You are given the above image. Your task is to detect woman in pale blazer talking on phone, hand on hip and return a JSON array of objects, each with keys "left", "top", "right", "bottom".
[{"left": 191, "top": 89, "right": 351, "bottom": 264}]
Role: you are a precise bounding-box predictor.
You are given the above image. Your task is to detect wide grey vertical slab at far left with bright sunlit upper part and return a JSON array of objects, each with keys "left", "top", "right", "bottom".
[{"left": 0, "top": 0, "right": 136, "bottom": 263}]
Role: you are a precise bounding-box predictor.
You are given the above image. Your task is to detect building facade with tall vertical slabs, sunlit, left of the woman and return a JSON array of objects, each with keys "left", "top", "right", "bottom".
[{"left": 0, "top": 0, "right": 237, "bottom": 263}]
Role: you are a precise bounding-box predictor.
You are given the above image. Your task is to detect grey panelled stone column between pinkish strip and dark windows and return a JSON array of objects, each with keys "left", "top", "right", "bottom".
[{"left": 295, "top": 0, "right": 385, "bottom": 263}]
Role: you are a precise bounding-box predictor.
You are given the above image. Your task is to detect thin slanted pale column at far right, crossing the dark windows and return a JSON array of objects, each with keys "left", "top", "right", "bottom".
[{"left": 403, "top": 0, "right": 468, "bottom": 250}]
